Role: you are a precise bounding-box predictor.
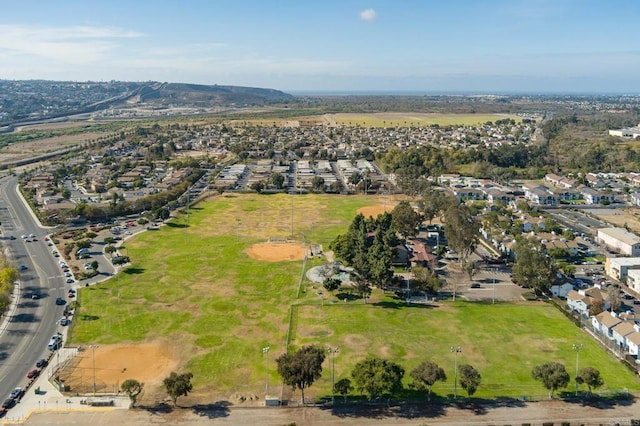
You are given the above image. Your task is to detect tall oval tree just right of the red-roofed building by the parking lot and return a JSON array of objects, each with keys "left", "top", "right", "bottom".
[{"left": 444, "top": 204, "right": 480, "bottom": 262}]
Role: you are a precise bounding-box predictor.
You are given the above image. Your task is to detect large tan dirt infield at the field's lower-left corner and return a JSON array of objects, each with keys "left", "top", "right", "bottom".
[{"left": 60, "top": 342, "right": 179, "bottom": 394}]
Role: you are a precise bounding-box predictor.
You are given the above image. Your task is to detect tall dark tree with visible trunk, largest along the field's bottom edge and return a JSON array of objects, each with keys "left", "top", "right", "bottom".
[{"left": 276, "top": 345, "right": 325, "bottom": 405}]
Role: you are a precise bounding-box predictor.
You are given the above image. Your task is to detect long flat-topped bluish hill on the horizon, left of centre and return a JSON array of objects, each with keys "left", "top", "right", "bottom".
[{"left": 137, "top": 83, "right": 295, "bottom": 106}]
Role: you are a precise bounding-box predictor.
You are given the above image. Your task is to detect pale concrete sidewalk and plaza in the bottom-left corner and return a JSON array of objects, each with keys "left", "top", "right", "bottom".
[{"left": 0, "top": 348, "right": 130, "bottom": 424}]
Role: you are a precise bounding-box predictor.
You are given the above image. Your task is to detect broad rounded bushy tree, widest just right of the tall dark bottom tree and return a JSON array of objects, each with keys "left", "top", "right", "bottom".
[{"left": 351, "top": 357, "right": 404, "bottom": 400}]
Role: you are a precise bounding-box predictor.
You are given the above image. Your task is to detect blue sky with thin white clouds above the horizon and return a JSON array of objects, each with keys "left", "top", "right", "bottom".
[{"left": 0, "top": 0, "right": 640, "bottom": 94}]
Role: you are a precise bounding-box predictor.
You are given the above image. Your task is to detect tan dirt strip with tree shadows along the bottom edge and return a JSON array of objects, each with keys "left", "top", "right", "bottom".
[{"left": 26, "top": 401, "right": 640, "bottom": 426}]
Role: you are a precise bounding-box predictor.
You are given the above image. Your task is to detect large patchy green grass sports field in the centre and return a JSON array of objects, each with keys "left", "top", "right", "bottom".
[{"left": 70, "top": 194, "right": 638, "bottom": 401}]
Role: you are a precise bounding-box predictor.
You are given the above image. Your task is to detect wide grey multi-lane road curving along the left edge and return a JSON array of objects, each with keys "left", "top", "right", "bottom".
[{"left": 0, "top": 176, "right": 68, "bottom": 400}]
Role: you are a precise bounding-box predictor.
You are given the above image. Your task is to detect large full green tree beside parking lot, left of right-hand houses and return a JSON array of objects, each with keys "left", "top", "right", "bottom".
[{"left": 513, "top": 238, "right": 556, "bottom": 294}]
